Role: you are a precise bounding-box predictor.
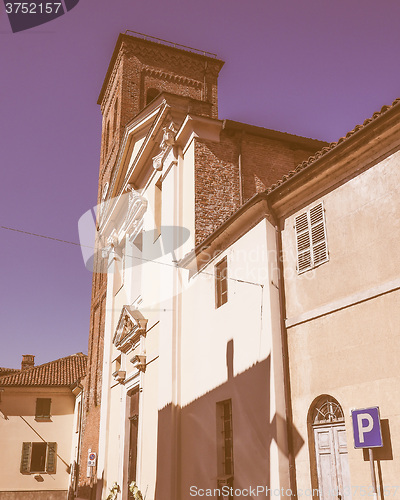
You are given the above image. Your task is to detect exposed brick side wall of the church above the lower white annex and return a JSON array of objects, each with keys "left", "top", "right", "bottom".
[{"left": 195, "top": 129, "right": 320, "bottom": 244}]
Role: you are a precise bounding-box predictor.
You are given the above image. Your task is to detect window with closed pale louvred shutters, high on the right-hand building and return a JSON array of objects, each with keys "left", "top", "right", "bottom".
[{"left": 295, "top": 203, "right": 329, "bottom": 274}]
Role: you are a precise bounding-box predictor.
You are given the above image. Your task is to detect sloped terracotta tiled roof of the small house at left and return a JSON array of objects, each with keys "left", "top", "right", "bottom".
[{"left": 0, "top": 352, "right": 87, "bottom": 387}]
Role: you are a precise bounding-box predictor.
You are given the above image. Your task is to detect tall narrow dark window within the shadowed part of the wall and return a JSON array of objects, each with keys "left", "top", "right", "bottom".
[{"left": 217, "top": 399, "right": 233, "bottom": 499}]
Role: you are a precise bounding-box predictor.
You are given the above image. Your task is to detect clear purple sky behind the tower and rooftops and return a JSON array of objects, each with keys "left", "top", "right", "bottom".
[{"left": 0, "top": 0, "right": 400, "bottom": 367}]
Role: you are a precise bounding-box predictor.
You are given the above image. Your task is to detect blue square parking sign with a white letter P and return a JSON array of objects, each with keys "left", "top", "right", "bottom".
[{"left": 351, "top": 406, "right": 383, "bottom": 448}]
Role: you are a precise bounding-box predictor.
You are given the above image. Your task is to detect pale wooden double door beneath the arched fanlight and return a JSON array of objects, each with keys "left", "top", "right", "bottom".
[{"left": 314, "top": 424, "right": 352, "bottom": 500}]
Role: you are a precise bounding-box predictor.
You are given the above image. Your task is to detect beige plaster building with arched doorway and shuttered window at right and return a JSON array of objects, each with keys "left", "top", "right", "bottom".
[{"left": 268, "top": 100, "right": 400, "bottom": 500}]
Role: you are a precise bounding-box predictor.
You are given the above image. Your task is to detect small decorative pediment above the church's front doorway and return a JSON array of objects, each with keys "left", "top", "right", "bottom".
[{"left": 113, "top": 306, "right": 148, "bottom": 353}]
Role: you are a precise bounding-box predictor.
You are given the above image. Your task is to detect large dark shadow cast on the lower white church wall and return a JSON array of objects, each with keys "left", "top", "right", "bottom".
[{"left": 155, "top": 340, "right": 304, "bottom": 500}]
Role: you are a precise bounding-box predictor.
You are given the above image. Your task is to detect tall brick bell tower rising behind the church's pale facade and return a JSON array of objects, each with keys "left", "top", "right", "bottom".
[{"left": 78, "top": 31, "right": 224, "bottom": 500}]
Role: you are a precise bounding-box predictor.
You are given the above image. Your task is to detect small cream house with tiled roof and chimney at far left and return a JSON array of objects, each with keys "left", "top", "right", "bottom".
[{"left": 0, "top": 353, "right": 87, "bottom": 500}]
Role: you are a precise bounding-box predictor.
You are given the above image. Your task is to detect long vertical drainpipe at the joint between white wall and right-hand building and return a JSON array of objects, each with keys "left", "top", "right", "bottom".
[{"left": 266, "top": 195, "right": 297, "bottom": 499}]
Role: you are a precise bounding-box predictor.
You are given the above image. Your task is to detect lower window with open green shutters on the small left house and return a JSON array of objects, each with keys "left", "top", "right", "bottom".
[{"left": 21, "top": 442, "right": 57, "bottom": 474}]
